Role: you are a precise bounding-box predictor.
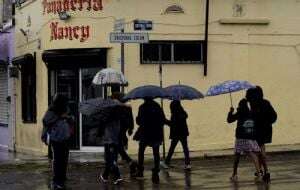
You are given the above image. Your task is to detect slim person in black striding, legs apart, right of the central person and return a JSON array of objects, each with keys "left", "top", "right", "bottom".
[{"left": 160, "top": 100, "right": 191, "bottom": 170}]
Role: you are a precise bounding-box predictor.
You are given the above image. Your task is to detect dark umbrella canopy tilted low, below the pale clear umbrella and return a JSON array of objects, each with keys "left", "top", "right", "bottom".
[{"left": 79, "top": 98, "right": 123, "bottom": 115}]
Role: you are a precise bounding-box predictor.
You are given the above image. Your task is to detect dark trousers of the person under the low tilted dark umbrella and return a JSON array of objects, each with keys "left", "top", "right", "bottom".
[{"left": 102, "top": 144, "right": 121, "bottom": 178}]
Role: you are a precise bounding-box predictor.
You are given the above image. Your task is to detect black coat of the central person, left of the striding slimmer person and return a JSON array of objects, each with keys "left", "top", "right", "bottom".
[{"left": 134, "top": 100, "right": 166, "bottom": 146}]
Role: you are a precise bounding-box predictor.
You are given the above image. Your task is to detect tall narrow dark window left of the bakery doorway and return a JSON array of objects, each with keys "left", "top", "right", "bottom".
[{"left": 21, "top": 57, "right": 36, "bottom": 123}]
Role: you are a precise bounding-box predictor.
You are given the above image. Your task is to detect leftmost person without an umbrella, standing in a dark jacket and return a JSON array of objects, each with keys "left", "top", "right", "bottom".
[{"left": 42, "top": 94, "right": 74, "bottom": 190}]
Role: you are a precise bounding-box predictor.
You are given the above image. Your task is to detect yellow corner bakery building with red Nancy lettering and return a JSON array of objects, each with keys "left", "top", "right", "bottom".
[{"left": 13, "top": 0, "right": 300, "bottom": 154}]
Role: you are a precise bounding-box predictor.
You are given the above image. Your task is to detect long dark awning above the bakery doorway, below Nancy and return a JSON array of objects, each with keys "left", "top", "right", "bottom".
[{"left": 42, "top": 48, "right": 106, "bottom": 69}]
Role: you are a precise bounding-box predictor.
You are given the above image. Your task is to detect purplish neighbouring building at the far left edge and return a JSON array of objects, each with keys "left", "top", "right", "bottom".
[{"left": 0, "top": 0, "right": 14, "bottom": 149}]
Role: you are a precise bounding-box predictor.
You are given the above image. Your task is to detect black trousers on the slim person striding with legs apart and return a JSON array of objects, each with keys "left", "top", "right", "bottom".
[{"left": 165, "top": 137, "right": 190, "bottom": 165}]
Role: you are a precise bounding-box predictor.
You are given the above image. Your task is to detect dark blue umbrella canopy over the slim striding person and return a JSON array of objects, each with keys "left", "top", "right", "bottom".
[{"left": 164, "top": 84, "right": 204, "bottom": 100}]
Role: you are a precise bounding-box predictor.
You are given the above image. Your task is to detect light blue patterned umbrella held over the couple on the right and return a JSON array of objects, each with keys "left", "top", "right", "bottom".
[{"left": 206, "top": 80, "right": 255, "bottom": 106}]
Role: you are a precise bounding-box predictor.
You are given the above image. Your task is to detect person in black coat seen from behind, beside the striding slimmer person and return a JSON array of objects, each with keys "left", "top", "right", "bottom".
[{"left": 134, "top": 97, "right": 166, "bottom": 184}]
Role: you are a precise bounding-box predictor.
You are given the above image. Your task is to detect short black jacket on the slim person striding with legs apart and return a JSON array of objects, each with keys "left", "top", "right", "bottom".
[{"left": 167, "top": 109, "right": 189, "bottom": 139}]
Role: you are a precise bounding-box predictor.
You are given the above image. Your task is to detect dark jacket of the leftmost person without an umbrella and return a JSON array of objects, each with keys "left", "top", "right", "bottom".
[{"left": 41, "top": 110, "right": 71, "bottom": 142}]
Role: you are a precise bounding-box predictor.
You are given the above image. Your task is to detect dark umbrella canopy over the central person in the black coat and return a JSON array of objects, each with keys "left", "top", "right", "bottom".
[{"left": 123, "top": 85, "right": 168, "bottom": 101}]
